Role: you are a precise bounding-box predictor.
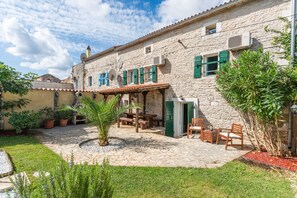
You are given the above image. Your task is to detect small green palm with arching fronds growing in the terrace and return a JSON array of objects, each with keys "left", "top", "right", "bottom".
[{"left": 74, "top": 96, "right": 132, "bottom": 146}]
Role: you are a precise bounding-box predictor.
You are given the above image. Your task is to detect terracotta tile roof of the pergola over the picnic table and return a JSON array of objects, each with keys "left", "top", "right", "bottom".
[{"left": 99, "top": 83, "right": 169, "bottom": 94}]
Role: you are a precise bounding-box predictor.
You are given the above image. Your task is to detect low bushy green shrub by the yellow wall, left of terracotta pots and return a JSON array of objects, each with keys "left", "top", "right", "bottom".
[{"left": 8, "top": 111, "right": 41, "bottom": 133}]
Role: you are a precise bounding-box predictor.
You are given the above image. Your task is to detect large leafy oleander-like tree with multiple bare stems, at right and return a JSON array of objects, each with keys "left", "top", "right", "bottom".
[{"left": 216, "top": 49, "right": 297, "bottom": 156}]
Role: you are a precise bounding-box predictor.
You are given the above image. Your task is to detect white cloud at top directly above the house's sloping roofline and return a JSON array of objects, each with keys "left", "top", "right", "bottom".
[{"left": 154, "top": 0, "right": 227, "bottom": 29}]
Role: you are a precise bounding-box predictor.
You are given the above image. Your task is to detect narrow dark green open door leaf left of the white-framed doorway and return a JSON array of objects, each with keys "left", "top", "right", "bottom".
[{"left": 165, "top": 101, "right": 174, "bottom": 137}]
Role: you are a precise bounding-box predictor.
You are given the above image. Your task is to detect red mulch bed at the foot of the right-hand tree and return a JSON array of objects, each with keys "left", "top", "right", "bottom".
[{"left": 242, "top": 151, "right": 297, "bottom": 172}]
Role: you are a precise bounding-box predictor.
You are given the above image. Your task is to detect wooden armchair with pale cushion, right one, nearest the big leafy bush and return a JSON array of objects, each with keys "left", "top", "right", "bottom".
[{"left": 217, "top": 123, "right": 243, "bottom": 150}]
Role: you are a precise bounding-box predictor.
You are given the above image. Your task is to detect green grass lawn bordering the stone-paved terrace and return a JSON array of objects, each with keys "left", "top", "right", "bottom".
[{"left": 0, "top": 136, "right": 294, "bottom": 197}]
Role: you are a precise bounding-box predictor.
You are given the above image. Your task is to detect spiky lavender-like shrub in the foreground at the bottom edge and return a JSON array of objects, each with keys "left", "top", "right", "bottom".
[{"left": 14, "top": 160, "right": 113, "bottom": 198}]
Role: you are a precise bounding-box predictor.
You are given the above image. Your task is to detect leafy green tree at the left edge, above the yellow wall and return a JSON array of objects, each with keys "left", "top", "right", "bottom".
[{"left": 0, "top": 62, "right": 37, "bottom": 129}]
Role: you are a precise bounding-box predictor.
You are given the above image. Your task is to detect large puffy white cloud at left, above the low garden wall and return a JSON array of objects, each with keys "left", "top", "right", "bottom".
[{"left": 1, "top": 18, "right": 73, "bottom": 78}]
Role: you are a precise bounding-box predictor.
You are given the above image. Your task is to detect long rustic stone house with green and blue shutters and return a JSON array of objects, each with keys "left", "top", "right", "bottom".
[{"left": 72, "top": 0, "right": 291, "bottom": 137}]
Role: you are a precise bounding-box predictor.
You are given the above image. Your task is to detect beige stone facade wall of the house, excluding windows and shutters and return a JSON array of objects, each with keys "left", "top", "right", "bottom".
[{"left": 73, "top": 0, "right": 291, "bottom": 136}]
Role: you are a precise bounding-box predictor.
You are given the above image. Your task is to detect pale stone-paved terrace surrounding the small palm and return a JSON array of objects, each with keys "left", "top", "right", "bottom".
[{"left": 37, "top": 125, "right": 250, "bottom": 168}]
